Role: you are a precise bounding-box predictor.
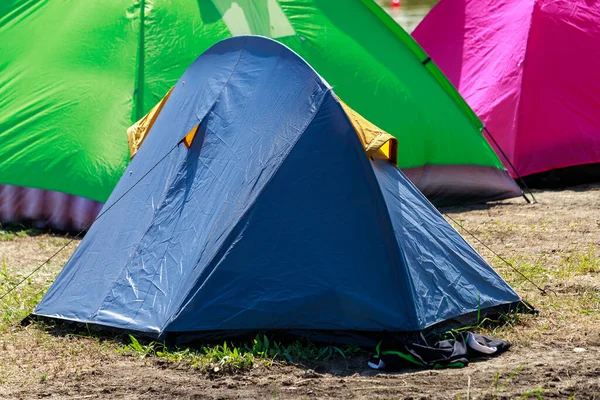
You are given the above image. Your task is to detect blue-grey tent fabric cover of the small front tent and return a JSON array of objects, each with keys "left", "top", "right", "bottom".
[{"left": 34, "top": 36, "right": 520, "bottom": 337}]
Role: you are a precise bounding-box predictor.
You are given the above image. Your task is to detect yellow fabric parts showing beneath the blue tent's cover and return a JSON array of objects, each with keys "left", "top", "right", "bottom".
[{"left": 127, "top": 88, "right": 398, "bottom": 166}]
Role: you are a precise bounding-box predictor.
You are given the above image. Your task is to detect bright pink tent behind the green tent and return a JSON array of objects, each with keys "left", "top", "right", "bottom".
[{"left": 413, "top": 0, "right": 600, "bottom": 181}]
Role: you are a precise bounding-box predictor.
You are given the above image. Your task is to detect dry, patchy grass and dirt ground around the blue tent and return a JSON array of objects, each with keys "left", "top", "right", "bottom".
[{"left": 0, "top": 185, "right": 600, "bottom": 399}]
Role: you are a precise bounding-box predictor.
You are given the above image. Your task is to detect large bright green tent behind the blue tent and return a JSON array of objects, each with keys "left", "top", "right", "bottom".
[{"left": 0, "top": 0, "right": 520, "bottom": 212}]
